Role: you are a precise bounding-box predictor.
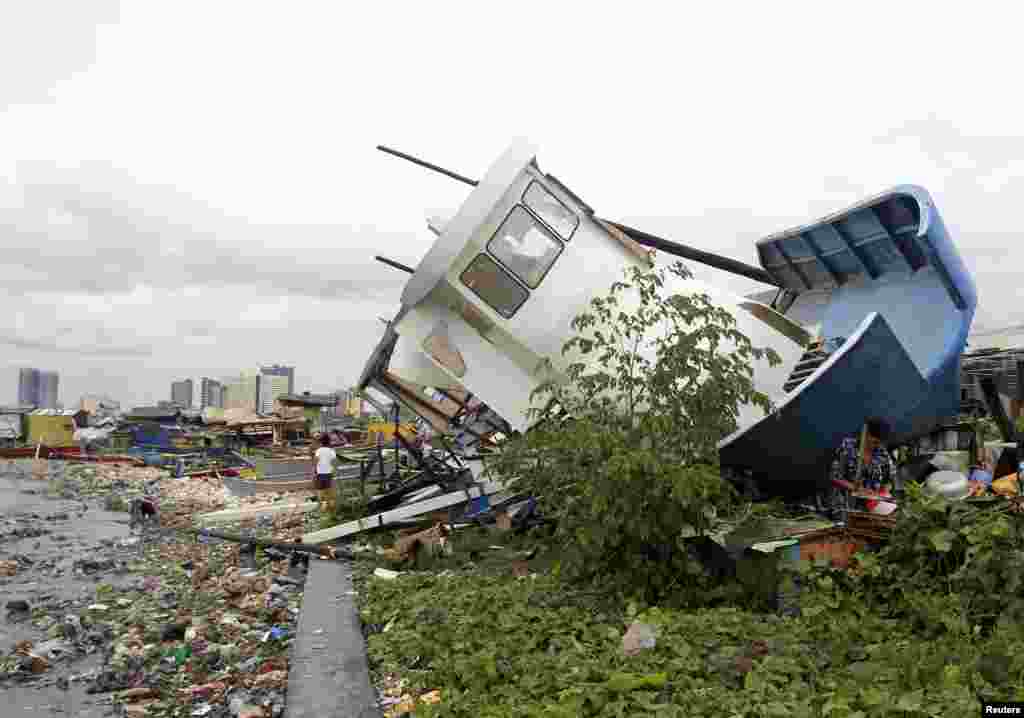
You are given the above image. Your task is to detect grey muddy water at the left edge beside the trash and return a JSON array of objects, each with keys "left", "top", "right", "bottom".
[{"left": 0, "top": 461, "right": 138, "bottom": 718}]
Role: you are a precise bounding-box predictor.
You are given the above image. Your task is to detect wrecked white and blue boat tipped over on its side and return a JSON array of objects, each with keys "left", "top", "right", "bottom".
[{"left": 359, "top": 140, "right": 977, "bottom": 493}]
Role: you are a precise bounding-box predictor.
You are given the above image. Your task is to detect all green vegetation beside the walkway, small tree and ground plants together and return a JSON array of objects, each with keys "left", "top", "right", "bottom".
[{"left": 356, "top": 265, "right": 1024, "bottom": 718}]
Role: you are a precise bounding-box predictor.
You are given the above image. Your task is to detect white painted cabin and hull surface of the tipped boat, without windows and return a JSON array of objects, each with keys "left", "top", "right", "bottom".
[{"left": 391, "top": 138, "right": 803, "bottom": 430}]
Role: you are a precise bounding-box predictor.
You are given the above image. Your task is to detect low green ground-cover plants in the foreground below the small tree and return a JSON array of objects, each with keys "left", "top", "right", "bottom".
[{"left": 356, "top": 567, "right": 1024, "bottom": 718}]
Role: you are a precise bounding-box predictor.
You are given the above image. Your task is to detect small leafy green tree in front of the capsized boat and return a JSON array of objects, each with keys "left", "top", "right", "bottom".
[{"left": 492, "top": 263, "right": 779, "bottom": 600}]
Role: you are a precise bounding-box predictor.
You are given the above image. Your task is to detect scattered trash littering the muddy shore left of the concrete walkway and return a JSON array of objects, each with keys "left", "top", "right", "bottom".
[{"left": 0, "top": 460, "right": 305, "bottom": 718}]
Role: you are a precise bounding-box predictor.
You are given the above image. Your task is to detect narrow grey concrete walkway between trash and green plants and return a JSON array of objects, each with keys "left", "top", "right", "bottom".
[{"left": 285, "top": 558, "right": 382, "bottom": 718}]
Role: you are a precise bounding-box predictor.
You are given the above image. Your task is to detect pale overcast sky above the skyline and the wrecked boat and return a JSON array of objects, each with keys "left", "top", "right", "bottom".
[{"left": 0, "top": 0, "right": 1024, "bottom": 406}]
